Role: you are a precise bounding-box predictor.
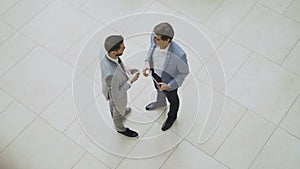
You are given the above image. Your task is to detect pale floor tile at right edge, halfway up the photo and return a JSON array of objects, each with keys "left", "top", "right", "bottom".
[{"left": 225, "top": 54, "right": 300, "bottom": 123}]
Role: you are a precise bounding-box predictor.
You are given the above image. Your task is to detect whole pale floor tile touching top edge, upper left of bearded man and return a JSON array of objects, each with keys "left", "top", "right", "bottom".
[{"left": 21, "top": 1, "right": 96, "bottom": 56}]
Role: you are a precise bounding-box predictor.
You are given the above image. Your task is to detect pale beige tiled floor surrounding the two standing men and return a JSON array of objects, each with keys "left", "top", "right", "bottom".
[{"left": 0, "top": 0, "right": 300, "bottom": 169}]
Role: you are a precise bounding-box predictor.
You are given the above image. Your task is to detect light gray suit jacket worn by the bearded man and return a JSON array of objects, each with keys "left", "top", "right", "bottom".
[{"left": 100, "top": 56, "right": 130, "bottom": 114}]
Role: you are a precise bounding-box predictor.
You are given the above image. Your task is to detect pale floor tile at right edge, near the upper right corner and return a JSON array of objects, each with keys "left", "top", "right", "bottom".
[{"left": 230, "top": 5, "right": 300, "bottom": 64}]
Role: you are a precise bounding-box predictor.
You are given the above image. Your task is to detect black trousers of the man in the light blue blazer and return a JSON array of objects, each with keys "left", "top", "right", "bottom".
[{"left": 151, "top": 71, "right": 179, "bottom": 120}]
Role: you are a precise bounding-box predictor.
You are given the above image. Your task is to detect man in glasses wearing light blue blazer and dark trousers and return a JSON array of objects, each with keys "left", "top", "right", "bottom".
[{"left": 143, "top": 22, "right": 189, "bottom": 131}]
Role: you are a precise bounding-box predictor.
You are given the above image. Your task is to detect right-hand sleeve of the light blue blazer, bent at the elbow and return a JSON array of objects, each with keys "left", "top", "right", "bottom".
[{"left": 168, "top": 53, "right": 189, "bottom": 90}]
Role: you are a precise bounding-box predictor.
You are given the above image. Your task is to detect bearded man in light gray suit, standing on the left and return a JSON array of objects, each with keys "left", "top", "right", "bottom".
[{"left": 100, "top": 35, "right": 139, "bottom": 137}]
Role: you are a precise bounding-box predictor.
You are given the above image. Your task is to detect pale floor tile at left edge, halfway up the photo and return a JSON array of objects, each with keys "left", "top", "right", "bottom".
[{"left": 0, "top": 47, "right": 73, "bottom": 113}]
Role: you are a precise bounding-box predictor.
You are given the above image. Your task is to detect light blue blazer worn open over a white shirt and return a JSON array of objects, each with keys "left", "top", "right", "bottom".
[{"left": 146, "top": 34, "right": 189, "bottom": 91}]
